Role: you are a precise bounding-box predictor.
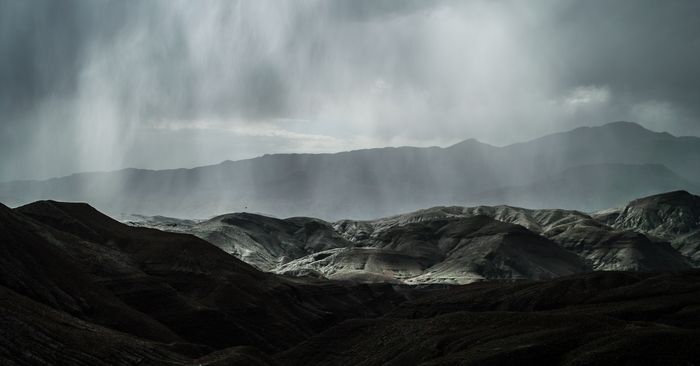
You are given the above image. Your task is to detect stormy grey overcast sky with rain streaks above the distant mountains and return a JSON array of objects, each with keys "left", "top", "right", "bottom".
[{"left": 0, "top": 0, "right": 700, "bottom": 180}]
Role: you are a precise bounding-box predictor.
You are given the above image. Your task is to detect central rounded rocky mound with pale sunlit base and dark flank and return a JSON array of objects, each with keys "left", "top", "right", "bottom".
[{"left": 278, "top": 216, "right": 586, "bottom": 284}]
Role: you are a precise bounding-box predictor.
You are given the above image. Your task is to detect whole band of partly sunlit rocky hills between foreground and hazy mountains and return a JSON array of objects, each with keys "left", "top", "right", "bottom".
[{"left": 129, "top": 191, "right": 700, "bottom": 284}]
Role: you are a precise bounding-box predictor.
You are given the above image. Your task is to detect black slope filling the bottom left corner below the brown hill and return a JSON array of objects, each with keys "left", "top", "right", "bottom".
[{"left": 0, "top": 286, "right": 189, "bottom": 366}]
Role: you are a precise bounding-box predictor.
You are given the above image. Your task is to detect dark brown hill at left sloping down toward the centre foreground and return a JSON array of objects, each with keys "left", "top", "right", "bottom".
[{"left": 0, "top": 201, "right": 410, "bottom": 354}]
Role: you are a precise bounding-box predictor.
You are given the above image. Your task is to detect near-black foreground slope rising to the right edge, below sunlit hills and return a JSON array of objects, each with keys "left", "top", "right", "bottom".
[{"left": 275, "top": 271, "right": 700, "bottom": 365}]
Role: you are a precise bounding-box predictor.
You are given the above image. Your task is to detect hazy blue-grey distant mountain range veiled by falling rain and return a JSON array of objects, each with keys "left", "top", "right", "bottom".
[{"left": 0, "top": 122, "right": 700, "bottom": 220}]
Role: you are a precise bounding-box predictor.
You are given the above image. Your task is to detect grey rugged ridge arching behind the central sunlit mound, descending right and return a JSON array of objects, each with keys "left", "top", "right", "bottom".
[{"left": 334, "top": 206, "right": 689, "bottom": 271}]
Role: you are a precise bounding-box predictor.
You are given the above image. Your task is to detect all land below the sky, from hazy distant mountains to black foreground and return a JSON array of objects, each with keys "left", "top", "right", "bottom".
[{"left": 0, "top": 122, "right": 700, "bottom": 366}]
